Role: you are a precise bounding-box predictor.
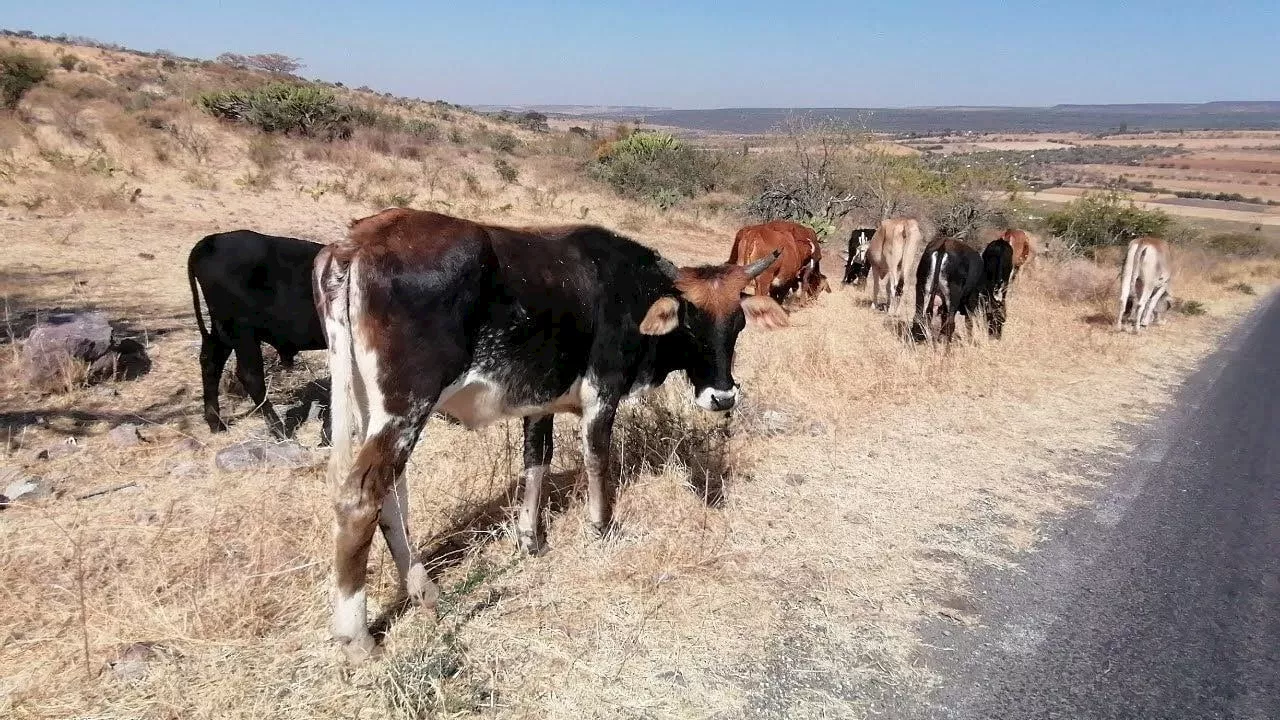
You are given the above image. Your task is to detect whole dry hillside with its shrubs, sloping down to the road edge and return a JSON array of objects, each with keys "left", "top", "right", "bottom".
[{"left": 0, "top": 30, "right": 1280, "bottom": 720}]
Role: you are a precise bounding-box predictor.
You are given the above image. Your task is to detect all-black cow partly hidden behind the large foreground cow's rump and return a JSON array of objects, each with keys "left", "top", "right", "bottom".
[{"left": 187, "top": 229, "right": 325, "bottom": 438}]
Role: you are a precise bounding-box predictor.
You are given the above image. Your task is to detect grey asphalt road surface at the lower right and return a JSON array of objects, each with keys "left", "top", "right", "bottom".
[{"left": 911, "top": 297, "right": 1280, "bottom": 720}]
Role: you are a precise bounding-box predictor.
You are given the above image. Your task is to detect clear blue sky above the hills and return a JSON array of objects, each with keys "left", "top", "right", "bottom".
[{"left": 0, "top": 0, "right": 1280, "bottom": 108}]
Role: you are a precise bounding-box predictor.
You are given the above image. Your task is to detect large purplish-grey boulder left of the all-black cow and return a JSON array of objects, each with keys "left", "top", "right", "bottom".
[{"left": 20, "top": 313, "right": 111, "bottom": 388}]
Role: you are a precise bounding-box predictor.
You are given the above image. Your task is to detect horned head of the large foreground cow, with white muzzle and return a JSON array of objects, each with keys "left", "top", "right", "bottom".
[{"left": 640, "top": 251, "right": 787, "bottom": 411}]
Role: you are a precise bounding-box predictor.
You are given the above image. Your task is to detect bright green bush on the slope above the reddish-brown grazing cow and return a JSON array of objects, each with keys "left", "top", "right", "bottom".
[{"left": 591, "top": 132, "right": 716, "bottom": 209}]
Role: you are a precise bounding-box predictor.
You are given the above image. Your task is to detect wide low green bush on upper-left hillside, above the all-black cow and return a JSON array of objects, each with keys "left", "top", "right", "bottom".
[{"left": 197, "top": 83, "right": 352, "bottom": 140}]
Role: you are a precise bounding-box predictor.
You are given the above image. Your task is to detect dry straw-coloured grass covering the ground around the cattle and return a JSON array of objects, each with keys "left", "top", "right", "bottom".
[{"left": 0, "top": 35, "right": 1277, "bottom": 719}]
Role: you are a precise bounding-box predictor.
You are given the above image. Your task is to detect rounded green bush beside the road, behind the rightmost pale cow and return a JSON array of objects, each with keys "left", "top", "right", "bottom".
[{"left": 1044, "top": 192, "right": 1174, "bottom": 247}]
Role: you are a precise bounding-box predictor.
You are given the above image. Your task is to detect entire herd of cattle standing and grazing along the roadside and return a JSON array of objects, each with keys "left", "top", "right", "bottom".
[{"left": 187, "top": 208, "right": 1170, "bottom": 659}]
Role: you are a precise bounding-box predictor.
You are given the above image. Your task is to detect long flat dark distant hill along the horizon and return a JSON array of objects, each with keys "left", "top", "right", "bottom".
[{"left": 476, "top": 101, "right": 1280, "bottom": 135}]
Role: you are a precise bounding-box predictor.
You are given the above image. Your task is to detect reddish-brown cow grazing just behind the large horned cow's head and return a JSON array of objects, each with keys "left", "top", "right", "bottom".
[{"left": 728, "top": 220, "right": 831, "bottom": 302}]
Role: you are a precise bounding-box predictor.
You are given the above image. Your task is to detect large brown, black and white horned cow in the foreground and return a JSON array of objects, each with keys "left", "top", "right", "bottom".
[{"left": 314, "top": 209, "right": 787, "bottom": 661}]
